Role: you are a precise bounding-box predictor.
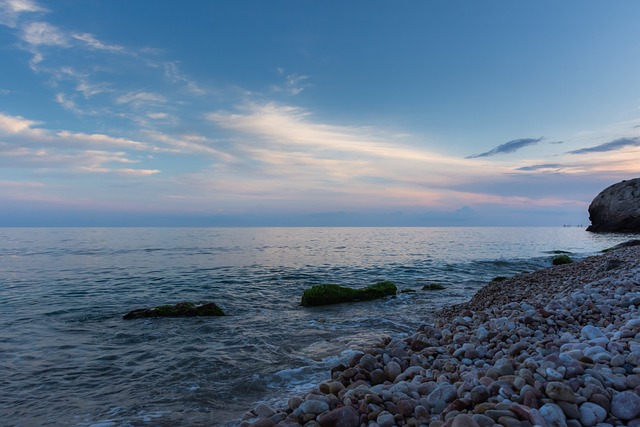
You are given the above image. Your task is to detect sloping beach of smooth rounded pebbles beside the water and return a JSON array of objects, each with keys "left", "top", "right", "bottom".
[{"left": 241, "top": 246, "right": 640, "bottom": 427}]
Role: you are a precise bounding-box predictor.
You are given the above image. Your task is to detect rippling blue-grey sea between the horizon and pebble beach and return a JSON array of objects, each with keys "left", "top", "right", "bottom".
[{"left": 0, "top": 227, "right": 630, "bottom": 427}]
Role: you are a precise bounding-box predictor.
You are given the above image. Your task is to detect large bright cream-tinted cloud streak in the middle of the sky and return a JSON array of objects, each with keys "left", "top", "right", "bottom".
[{"left": 206, "top": 103, "right": 495, "bottom": 204}]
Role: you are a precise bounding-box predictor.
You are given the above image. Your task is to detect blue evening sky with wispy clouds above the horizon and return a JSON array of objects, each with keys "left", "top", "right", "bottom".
[{"left": 0, "top": 0, "right": 640, "bottom": 226}]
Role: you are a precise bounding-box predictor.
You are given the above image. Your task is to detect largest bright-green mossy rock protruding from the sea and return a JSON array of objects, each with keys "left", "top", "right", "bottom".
[{"left": 300, "top": 280, "right": 398, "bottom": 307}]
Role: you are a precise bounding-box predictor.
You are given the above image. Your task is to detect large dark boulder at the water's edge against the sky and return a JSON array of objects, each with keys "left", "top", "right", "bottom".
[{"left": 587, "top": 178, "right": 640, "bottom": 233}]
